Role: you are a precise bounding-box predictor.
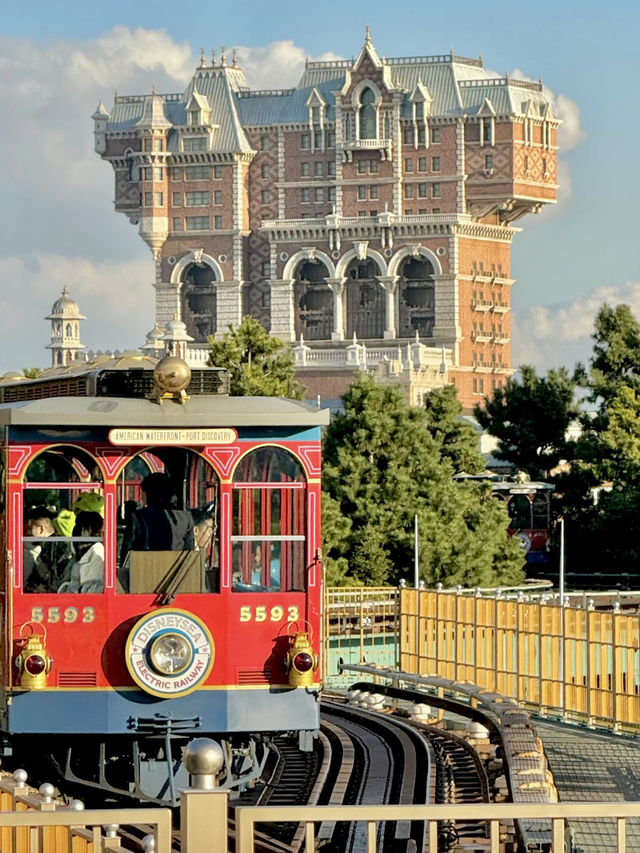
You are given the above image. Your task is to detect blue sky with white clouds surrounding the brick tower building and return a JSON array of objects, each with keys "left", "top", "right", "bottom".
[{"left": 0, "top": 0, "right": 640, "bottom": 372}]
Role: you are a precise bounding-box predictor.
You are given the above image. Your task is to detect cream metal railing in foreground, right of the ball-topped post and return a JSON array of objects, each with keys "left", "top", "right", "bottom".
[{"left": 235, "top": 802, "right": 640, "bottom": 853}]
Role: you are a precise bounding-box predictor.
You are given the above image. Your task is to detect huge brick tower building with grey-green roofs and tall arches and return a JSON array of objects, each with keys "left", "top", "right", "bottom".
[{"left": 93, "top": 32, "right": 558, "bottom": 406}]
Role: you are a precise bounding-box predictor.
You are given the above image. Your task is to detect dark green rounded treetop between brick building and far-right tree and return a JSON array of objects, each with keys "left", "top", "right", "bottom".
[{"left": 474, "top": 365, "right": 578, "bottom": 480}]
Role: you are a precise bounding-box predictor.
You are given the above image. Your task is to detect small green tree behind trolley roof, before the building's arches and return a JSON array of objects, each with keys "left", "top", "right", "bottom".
[{"left": 209, "top": 315, "right": 304, "bottom": 400}]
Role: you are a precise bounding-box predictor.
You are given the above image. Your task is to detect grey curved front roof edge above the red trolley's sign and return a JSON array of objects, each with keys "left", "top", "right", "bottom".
[{"left": 0, "top": 396, "right": 330, "bottom": 427}]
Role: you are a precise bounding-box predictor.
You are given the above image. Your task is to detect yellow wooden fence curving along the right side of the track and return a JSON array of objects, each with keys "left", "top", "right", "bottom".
[{"left": 399, "top": 589, "right": 640, "bottom": 730}]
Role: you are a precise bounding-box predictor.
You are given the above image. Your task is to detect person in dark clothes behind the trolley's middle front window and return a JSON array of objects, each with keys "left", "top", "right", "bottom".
[{"left": 121, "top": 472, "right": 195, "bottom": 563}]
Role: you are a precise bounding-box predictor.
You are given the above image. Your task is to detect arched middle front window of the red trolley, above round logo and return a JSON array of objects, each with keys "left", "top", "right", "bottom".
[{"left": 117, "top": 447, "right": 219, "bottom": 601}]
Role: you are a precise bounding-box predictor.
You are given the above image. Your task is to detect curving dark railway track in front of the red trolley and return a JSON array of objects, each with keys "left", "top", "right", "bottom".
[{"left": 21, "top": 684, "right": 500, "bottom": 853}]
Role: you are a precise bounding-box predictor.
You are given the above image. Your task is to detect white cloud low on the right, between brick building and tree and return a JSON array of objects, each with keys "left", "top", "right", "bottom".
[{"left": 511, "top": 282, "right": 640, "bottom": 372}]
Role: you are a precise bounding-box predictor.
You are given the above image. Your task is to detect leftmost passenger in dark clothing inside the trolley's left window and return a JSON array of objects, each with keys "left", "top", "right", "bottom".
[{"left": 24, "top": 506, "right": 74, "bottom": 592}]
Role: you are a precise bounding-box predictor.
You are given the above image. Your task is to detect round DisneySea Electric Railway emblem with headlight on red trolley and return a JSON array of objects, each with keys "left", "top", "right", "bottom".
[{"left": 125, "top": 607, "right": 215, "bottom": 697}]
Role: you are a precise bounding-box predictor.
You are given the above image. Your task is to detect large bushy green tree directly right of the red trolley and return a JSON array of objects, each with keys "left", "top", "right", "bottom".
[{"left": 323, "top": 376, "right": 524, "bottom": 586}]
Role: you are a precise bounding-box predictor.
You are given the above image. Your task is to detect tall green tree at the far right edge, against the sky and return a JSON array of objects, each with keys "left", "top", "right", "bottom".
[{"left": 556, "top": 305, "right": 640, "bottom": 580}]
